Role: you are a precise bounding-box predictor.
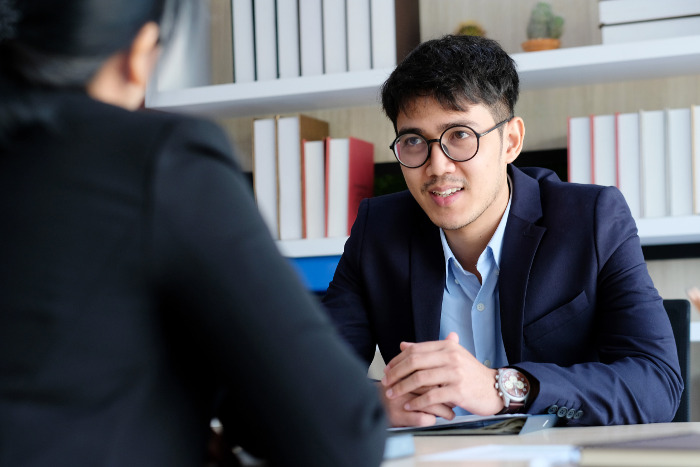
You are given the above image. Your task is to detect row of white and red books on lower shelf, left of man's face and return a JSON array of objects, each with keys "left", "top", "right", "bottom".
[{"left": 253, "top": 114, "right": 374, "bottom": 240}]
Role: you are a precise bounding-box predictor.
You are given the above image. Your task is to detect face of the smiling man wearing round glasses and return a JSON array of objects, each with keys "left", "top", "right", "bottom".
[{"left": 396, "top": 97, "right": 517, "bottom": 234}]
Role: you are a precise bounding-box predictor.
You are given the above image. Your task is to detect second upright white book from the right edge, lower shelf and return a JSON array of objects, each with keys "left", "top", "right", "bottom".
[{"left": 666, "top": 108, "right": 693, "bottom": 216}]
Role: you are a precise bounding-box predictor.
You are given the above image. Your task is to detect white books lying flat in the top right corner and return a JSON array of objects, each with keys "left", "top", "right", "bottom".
[{"left": 598, "top": 0, "right": 700, "bottom": 44}]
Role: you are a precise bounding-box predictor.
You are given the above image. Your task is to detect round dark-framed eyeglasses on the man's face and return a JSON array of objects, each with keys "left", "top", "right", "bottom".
[{"left": 389, "top": 115, "right": 513, "bottom": 169}]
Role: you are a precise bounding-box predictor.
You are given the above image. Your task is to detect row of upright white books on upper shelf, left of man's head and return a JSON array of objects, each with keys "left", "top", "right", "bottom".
[{"left": 212, "top": 0, "right": 420, "bottom": 83}]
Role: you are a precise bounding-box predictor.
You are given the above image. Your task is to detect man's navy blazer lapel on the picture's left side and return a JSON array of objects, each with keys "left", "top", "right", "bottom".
[{"left": 408, "top": 205, "right": 445, "bottom": 342}]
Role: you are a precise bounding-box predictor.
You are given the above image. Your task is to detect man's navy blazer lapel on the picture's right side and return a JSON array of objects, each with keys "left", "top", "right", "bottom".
[{"left": 498, "top": 165, "right": 547, "bottom": 363}]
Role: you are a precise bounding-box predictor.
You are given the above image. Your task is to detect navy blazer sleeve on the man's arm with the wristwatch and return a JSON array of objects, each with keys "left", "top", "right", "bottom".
[{"left": 514, "top": 188, "right": 683, "bottom": 425}]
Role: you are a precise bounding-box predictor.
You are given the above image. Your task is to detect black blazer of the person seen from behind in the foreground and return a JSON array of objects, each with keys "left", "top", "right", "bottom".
[{"left": 0, "top": 93, "right": 386, "bottom": 467}]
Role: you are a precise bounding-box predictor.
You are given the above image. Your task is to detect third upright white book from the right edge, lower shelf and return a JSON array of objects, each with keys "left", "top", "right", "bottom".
[{"left": 639, "top": 110, "right": 668, "bottom": 218}]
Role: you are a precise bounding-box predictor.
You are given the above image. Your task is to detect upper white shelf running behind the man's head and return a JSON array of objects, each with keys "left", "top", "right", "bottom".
[{"left": 146, "top": 35, "right": 700, "bottom": 117}]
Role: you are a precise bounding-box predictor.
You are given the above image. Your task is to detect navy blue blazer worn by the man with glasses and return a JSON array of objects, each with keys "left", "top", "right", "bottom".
[{"left": 324, "top": 166, "right": 683, "bottom": 425}]
